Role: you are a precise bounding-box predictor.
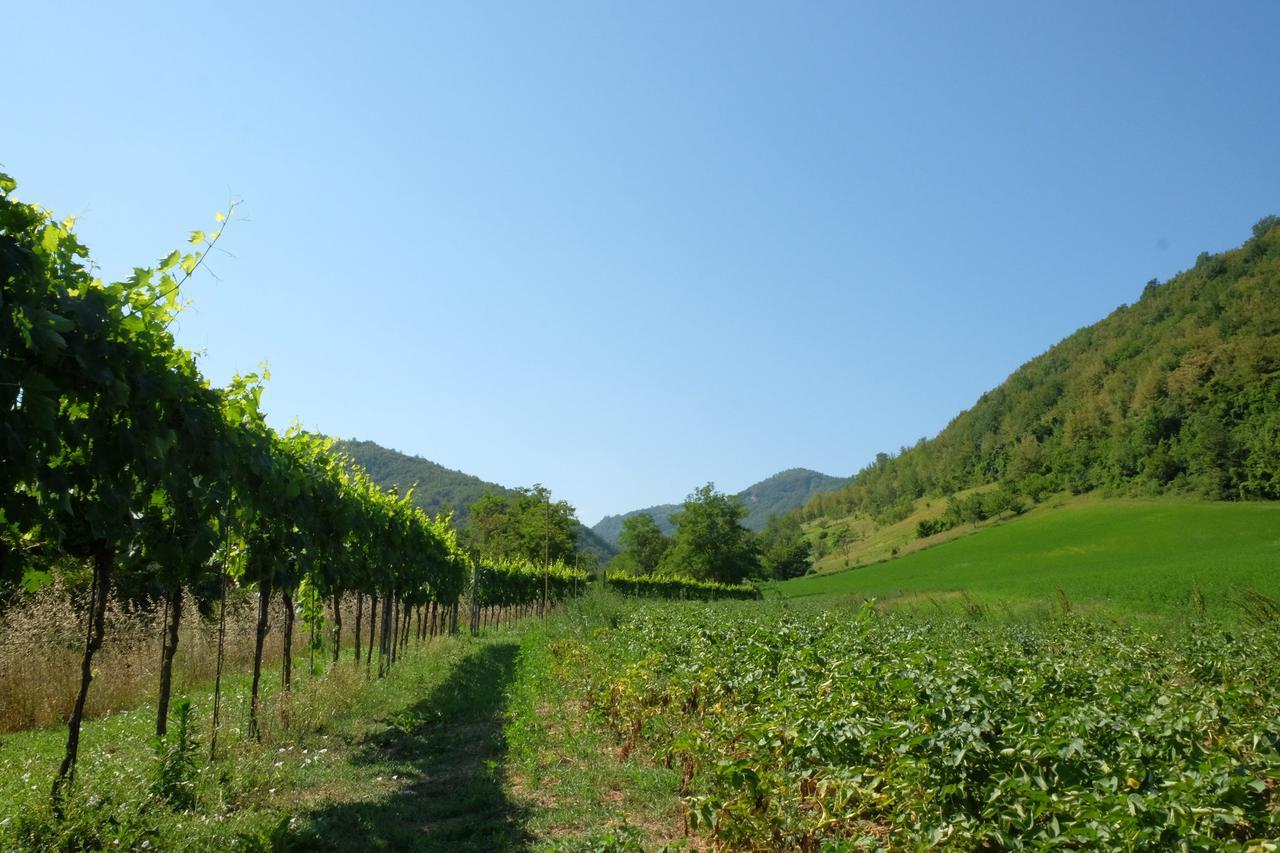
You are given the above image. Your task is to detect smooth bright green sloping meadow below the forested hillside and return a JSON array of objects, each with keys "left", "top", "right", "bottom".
[{"left": 780, "top": 500, "right": 1280, "bottom": 620}]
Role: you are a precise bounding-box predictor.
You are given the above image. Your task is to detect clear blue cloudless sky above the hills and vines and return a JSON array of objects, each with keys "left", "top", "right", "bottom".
[{"left": 0, "top": 0, "right": 1280, "bottom": 524}]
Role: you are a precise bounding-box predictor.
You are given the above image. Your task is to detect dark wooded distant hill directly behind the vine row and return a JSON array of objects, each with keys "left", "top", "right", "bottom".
[{"left": 337, "top": 438, "right": 616, "bottom": 562}]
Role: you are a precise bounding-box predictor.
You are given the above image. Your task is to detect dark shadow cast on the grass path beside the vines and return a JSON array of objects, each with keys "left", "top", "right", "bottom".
[{"left": 285, "top": 642, "right": 529, "bottom": 852}]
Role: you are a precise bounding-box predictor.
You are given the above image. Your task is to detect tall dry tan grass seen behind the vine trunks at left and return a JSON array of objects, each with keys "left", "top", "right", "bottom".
[{"left": 0, "top": 581, "right": 309, "bottom": 731}]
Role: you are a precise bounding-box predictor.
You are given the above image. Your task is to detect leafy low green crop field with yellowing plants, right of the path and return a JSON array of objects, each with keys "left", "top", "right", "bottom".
[{"left": 558, "top": 605, "right": 1280, "bottom": 850}]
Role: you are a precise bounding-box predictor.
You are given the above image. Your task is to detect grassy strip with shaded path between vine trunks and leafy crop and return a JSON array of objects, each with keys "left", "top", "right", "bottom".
[{"left": 0, "top": 597, "right": 682, "bottom": 853}]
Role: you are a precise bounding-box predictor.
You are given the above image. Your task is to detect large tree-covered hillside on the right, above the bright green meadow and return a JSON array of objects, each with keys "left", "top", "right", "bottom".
[{"left": 800, "top": 216, "right": 1280, "bottom": 520}]
